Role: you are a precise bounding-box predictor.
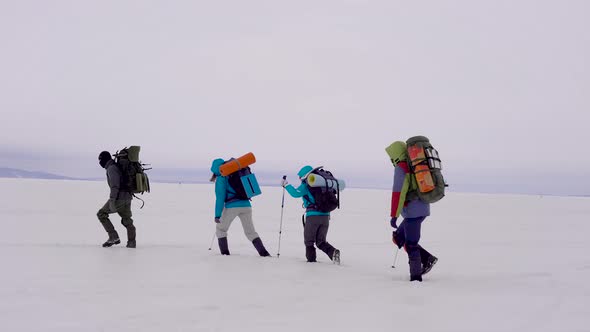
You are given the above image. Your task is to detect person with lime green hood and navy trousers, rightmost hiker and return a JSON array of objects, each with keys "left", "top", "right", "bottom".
[{"left": 385, "top": 141, "right": 438, "bottom": 281}]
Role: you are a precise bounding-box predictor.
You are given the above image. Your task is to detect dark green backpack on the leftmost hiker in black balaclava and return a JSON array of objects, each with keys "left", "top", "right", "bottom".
[{"left": 115, "top": 145, "right": 151, "bottom": 197}]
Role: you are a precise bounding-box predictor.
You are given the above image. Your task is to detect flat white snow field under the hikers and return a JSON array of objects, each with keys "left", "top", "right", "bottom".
[{"left": 0, "top": 179, "right": 590, "bottom": 332}]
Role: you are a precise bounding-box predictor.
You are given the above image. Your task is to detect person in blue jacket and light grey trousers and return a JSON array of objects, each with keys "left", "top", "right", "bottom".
[{"left": 211, "top": 159, "right": 270, "bottom": 257}]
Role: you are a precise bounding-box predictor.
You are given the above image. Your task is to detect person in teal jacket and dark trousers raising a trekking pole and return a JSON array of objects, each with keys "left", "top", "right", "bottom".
[{"left": 281, "top": 166, "right": 340, "bottom": 264}]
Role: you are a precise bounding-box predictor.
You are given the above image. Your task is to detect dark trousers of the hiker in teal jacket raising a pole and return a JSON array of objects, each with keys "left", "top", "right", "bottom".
[{"left": 303, "top": 216, "right": 336, "bottom": 261}]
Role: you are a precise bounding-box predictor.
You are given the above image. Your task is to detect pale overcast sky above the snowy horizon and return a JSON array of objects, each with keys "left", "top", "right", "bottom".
[{"left": 0, "top": 0, "right": 590, "bottom": 195}]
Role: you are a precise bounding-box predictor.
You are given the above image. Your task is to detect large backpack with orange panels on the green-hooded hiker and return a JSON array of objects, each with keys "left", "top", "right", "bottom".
[{"left": 406, "top": 136, "right": 447, "bottom": 203}]
